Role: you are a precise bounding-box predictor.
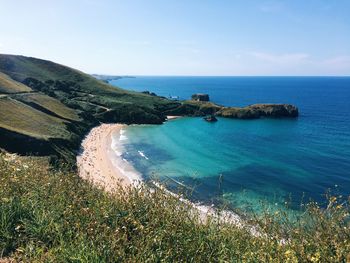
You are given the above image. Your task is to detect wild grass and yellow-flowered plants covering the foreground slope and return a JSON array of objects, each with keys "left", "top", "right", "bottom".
[{"left": 0, "top": 154, "right": 350, "bottom": 262}]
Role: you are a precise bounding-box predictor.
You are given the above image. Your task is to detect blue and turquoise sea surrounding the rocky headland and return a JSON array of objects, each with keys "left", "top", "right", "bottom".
[{"left": 111, "top": 77, "right": 350, "bottom": 216}]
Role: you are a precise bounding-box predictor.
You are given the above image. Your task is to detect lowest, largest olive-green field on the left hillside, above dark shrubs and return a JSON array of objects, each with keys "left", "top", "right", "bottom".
[{"left": 0, "top": 98, "right": 70, "bottom": 140}]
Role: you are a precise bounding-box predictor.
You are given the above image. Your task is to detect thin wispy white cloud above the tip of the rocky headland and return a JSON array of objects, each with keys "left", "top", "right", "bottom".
[{"left": 250, "top": 52, "right": 309, "bottom": 64}]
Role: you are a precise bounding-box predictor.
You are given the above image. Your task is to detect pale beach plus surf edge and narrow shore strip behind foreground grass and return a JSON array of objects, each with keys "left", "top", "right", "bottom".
[{"left": 77, "top": 124, "right": 260, "bottom": 236}]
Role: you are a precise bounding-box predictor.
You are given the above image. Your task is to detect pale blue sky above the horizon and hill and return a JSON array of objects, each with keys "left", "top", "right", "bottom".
[{"left": 0, "top": 0, "right": 350, "bottom": 76}]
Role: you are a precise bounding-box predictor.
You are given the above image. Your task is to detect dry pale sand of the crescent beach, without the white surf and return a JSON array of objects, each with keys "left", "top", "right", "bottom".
[{"left": 77, "top": 124, "right": 140, "bottom": 191}]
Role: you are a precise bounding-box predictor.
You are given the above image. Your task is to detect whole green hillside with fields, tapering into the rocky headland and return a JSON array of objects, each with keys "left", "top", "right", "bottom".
[{"left": 0, "top": 54, "right": 298, "bottom": 163}]
